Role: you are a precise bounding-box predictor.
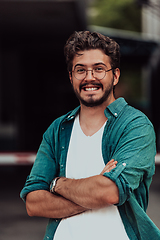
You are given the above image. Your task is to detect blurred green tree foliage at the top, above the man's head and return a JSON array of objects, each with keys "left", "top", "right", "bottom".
[{"left": 88, "top": 0, "right": 141, "bottom": 32}]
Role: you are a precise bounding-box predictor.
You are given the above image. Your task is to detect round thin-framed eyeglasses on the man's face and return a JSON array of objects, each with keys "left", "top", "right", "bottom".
[{"left": 72, "top": 66, "right": 113, "bottom": 80}]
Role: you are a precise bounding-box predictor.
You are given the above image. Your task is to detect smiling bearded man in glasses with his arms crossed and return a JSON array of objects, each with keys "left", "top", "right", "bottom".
[{"left": 21, "top": 31, "right": 160, "bottom": 240}]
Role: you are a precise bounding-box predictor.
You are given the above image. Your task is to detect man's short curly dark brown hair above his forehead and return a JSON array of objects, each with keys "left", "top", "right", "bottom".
[{"left": 64, "top": 31, "right": 120, "bottom": 73}]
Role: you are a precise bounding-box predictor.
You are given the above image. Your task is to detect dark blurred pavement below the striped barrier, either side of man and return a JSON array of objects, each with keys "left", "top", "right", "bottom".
[{"left": 0, "top": 165, "right": 160, "bottom": 240}]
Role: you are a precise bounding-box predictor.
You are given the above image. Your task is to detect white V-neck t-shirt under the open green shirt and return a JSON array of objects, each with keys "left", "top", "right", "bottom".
[{"left": 54, "top": 116, "right": 129, "bottom": 240}]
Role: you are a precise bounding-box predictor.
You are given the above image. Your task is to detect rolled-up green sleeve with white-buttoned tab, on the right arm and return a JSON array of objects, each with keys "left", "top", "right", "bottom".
[{"left": 104, "top": 119, "right": 156, "bottom": 206}]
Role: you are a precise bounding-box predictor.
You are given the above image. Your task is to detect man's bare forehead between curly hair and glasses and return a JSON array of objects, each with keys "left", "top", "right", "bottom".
[{"left": 73, "top": 49, "right": 110, "bottom": 67}]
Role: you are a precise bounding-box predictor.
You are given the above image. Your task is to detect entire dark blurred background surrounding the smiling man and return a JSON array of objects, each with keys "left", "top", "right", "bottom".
[{"left": 0, "top": 0, "right": 160, "bottom": 240}]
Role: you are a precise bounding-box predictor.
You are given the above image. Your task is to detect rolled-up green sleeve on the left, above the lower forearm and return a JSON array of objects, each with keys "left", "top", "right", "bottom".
[{"left": 20, "top": 126, "right": 57, "bottom": 201}]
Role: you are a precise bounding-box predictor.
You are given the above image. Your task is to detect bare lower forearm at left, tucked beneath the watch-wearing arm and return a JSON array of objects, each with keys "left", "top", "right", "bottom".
[{"left": 26, "top": 190, "right": 89, "bottom": 218}]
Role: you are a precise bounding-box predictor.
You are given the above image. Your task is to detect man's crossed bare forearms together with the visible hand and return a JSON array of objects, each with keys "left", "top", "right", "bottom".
[{"left": 26, "top": 159, "right": 119, "bottom": 218}]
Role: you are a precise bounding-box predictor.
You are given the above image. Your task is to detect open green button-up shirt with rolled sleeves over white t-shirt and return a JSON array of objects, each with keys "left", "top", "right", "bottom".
[{"left": 21, "top": 98, "right": 160, "bottom": 240}]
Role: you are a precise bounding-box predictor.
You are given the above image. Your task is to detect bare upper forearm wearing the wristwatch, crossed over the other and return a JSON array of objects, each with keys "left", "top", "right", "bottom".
[{"left": 55, "top": 175, "right": 119, "bottom": 209}]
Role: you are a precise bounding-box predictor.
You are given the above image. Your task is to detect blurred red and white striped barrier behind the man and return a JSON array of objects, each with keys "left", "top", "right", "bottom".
[{"left": 0, "top": 152, "right": 160, "bottom": 165}]
